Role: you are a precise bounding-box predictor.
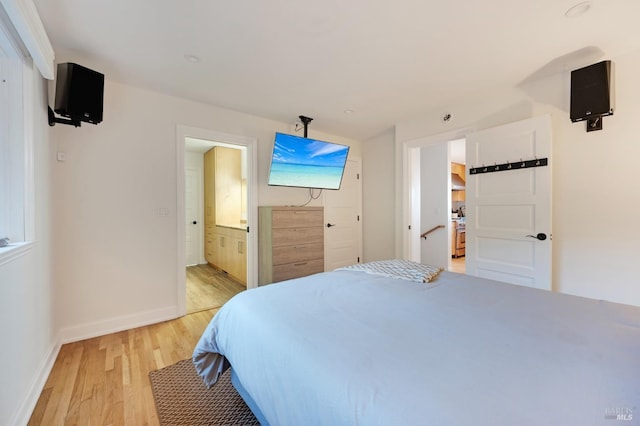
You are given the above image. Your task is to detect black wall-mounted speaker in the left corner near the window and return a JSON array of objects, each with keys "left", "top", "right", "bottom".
[{"left": 49, "top": 62, "right": 104, "bottom": 127}]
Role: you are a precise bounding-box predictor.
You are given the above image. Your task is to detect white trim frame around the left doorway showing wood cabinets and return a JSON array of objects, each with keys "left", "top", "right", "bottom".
[{"left": 176, "top": 124, "right": 258, "bottom": 316}]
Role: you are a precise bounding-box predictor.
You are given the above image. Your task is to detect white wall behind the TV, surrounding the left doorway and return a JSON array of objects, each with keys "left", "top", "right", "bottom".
[{"left": 51, "top": 78, "right": 361, "bottom": 341}]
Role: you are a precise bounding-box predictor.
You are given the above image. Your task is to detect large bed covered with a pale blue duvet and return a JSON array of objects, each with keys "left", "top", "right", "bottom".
[{"left": 193, "top": 262, "right": 640, "bottom": 426}]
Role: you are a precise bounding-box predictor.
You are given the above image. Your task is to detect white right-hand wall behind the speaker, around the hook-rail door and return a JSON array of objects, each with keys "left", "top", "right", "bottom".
[{"left": 396, "top": 47, "right": 640, "bottom": 305}]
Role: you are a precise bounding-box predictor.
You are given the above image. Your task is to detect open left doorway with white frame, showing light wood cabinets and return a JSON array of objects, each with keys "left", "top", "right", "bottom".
[{"left": 176, "top": 126, "right": 257, "bottom": 315}]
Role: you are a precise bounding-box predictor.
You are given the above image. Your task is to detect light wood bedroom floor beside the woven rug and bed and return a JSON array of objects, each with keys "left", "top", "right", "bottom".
[{"left": 29, "top": 310, "right": 217, "bottom": 426}]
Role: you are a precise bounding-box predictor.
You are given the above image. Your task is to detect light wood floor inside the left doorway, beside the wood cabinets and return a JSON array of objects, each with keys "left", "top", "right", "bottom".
[{"left": 187, "top": 264, "right": 247, "bottom": 313}]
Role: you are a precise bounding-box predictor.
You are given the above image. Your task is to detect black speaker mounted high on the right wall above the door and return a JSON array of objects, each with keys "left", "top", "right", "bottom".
[{"left": 569, "top": 61, "right": 614, "bottom": 131}]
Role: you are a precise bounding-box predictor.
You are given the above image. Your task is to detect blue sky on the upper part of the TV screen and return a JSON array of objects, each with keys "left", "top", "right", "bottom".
[{"left": 273, "top": 133, "right": 349, "bottom": 167}]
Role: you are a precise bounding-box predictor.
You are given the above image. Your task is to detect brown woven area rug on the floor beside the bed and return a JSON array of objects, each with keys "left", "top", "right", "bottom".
[{"left": 149, "top": 359, "right": 260, "bottom": 426}]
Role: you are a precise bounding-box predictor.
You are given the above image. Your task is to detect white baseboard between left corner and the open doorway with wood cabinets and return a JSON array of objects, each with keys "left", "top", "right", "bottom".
[{"left": 59, "top": 306, "right": 180, "bottom": 344}]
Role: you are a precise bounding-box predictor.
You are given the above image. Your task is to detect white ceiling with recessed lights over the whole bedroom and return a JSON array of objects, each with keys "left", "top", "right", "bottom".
[{"left": 34, "top": 0, "right": 640, "bottom": 139}]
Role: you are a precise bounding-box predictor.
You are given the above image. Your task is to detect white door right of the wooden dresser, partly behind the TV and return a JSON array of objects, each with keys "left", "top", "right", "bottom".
[{"left": 324, "top": 160, "right": 362, "bottom": 271}]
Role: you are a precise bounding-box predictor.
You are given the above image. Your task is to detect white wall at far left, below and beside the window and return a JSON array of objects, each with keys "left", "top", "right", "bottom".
[{"left": 0, "top": 71, "right": 58, "bottom": 425}]
